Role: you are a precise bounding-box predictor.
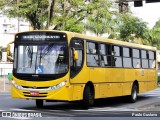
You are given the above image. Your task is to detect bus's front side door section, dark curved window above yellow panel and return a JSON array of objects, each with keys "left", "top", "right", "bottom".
[{"left": 70, "top": 38, "right": 85, "bottom": 100}]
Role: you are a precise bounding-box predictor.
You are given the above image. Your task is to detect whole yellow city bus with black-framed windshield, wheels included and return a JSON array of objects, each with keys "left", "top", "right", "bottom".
[{"left": 11, "top": 30, "right": 157, "bottom": 108}]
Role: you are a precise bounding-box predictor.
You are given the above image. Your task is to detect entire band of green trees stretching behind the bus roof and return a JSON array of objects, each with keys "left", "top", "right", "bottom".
[{"left": 0, "top": 0, "right": 156, "bottom": 46}]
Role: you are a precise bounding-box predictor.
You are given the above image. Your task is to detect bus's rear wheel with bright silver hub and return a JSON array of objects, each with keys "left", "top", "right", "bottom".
[{"left": 129, "top": 84, "right": 138, "bottom": 103}]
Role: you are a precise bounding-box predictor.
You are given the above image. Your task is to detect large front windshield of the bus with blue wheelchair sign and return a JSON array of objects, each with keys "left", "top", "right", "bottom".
[{"left": 15, "top": 43, "right": 68, "bottom": 74}]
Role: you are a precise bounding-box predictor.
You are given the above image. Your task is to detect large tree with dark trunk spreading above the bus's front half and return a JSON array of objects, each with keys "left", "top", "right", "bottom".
[{"left": 0, "top": 0, "right": 111, "bottom": 32}]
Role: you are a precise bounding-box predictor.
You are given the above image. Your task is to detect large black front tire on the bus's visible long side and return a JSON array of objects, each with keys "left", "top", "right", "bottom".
[{"left": 82, "top": 85, "right": 94, "bottom": 109}]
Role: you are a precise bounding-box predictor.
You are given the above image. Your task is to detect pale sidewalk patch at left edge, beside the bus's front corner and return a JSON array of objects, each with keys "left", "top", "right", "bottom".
[{"left": 0, "top": 76, "right": 11, "bottom": 92}]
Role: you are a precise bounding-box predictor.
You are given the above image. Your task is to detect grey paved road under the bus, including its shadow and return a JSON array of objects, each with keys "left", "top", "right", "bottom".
[{"left": 0, "top": 88, "right": 160, "bottom": 120}]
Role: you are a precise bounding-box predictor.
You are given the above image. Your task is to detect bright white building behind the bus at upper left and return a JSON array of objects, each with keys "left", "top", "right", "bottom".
[{"left": 0, "top": 13, "right": 30, "bottom": 47}]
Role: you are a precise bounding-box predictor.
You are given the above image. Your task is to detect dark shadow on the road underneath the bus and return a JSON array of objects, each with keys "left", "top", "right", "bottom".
[{"left": 21, "top": 95, "right": 152, "bottom": 110}]
